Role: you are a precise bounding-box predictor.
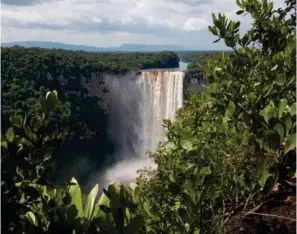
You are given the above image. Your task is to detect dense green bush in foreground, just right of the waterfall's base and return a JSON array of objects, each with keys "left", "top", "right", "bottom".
[{"left": 139, "top": 94, "right": 278, "bottom": 233}]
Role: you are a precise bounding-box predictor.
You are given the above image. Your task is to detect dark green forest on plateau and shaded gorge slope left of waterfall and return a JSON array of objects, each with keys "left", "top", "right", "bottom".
[{"left": 1, "top": 49, "right": 179, "bottom": 185}]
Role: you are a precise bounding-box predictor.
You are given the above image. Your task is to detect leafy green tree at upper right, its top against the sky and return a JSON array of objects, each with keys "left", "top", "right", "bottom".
[{"left": 204, "top": 1, "right": 296, "bottom": 153}]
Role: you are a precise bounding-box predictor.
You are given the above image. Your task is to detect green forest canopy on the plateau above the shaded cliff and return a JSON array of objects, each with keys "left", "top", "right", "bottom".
[{"left": 1, "top": 46, "right": 179, "bottom": 126}]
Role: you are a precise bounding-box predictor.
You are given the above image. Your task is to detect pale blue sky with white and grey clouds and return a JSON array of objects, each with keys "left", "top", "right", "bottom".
[{"left": 1, "top": 0, "right": 284, "bottom": 50}]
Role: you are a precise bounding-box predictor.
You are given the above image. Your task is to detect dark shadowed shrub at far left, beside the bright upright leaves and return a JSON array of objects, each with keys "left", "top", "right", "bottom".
[{"left": 1, "top": 91, "right": 67, "bottom": 233}]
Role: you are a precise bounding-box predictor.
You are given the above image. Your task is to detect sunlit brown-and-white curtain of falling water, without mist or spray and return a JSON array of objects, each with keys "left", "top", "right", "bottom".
[{"left": 142, "top": 71, "right": 184, "bottom": 154}]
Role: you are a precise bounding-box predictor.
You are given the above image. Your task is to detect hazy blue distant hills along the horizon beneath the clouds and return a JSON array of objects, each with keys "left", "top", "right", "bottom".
[{"left": 1, "top": 41, "right": 187, "bottom": 52}]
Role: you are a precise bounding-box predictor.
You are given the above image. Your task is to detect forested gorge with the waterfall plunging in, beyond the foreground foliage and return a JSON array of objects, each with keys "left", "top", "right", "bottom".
[{"left": 1, "top": 47, "right": 207, "bottom": 190}]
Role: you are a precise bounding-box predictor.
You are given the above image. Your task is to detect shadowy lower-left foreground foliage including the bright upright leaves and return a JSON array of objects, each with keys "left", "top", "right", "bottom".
[{"left": 1, "top": 90, "right": 143, "bottom": 234}]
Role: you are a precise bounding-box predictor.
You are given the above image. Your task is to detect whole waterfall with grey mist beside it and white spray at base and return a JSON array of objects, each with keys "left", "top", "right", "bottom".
[{"left": 84, "top": 69, "right": 184, "bottom": 187}]
